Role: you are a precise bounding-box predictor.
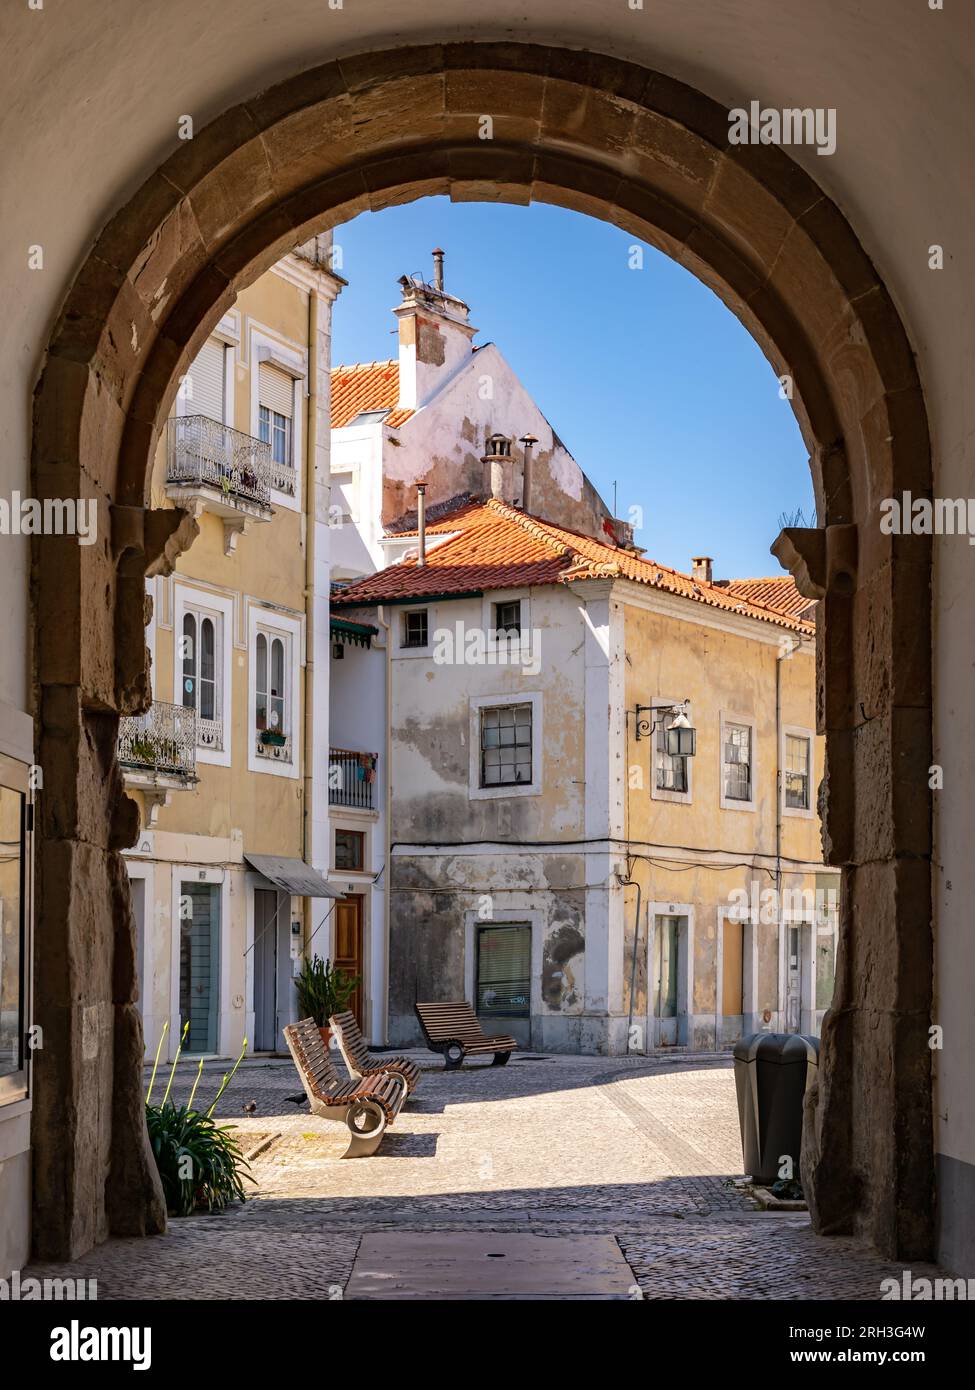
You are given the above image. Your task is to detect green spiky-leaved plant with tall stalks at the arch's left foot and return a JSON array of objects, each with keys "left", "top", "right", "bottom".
[{"left": 146, "top": 1024, "right": 255, "bottom": 1216}]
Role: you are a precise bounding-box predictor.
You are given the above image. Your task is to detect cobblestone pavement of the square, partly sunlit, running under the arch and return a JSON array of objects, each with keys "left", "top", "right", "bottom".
[{"left": 31, "top": 1052, "right": 933, "bottom": 1300}]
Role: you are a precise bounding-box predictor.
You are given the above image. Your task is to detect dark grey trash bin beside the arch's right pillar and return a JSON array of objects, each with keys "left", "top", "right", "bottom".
[{"left": 734, "top": 1033, "right": 819, "bottom": 1183}]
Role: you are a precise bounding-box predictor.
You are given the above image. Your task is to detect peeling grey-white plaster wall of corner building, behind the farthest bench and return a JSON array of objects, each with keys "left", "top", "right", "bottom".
[{"left": 375, "top": 588, "right": 609, "bottom": 1051}]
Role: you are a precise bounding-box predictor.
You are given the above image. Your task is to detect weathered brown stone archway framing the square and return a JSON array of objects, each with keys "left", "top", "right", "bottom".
[{"left": 32, "top": 43, "right": 933, "bottom": 1258}]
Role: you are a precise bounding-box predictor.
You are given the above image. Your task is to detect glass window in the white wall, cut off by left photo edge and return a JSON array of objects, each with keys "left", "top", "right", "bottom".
[{"left": 0, "top": 758, "right": 28, "bottom": 1104}]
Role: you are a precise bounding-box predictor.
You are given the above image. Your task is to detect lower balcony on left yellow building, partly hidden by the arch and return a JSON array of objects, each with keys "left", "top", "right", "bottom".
[{"left": 117, "top": 701, "right": 199, "bottom": 826}]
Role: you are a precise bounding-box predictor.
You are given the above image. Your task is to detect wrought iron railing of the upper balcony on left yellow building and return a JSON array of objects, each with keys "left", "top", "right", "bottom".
[{"left": 166, "top": 416, "right": 272, "bottom": 507}]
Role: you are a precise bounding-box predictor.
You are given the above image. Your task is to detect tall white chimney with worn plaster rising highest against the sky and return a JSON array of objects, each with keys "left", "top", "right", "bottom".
[{"left": 394, "top": 247, "right": 477, "bottom": 410}]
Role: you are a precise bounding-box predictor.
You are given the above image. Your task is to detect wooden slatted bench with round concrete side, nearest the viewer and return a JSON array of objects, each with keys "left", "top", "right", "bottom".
[{"left": 284, "top": 1019, "right": 406, "bottom": 1158}]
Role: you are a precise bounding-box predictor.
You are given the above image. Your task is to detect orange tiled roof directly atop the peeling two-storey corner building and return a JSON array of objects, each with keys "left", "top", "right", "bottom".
[{"left": 332, "top": 498, "right": 815, "bottom": 635}]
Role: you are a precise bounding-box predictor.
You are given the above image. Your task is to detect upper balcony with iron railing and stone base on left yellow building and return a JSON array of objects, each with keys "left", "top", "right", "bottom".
[{"left": 166, "top": 416, "right": 274, "bottom": 555}]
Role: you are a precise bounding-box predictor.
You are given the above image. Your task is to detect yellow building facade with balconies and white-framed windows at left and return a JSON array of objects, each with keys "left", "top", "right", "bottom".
[{"left": 120, "top": 238, "right": 342, "bottom": 1056}]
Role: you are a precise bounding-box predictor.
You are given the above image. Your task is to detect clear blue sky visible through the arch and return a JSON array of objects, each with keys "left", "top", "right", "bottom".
[{"left": 332, "top": 197, "right": 812, "bottom": 578}]
